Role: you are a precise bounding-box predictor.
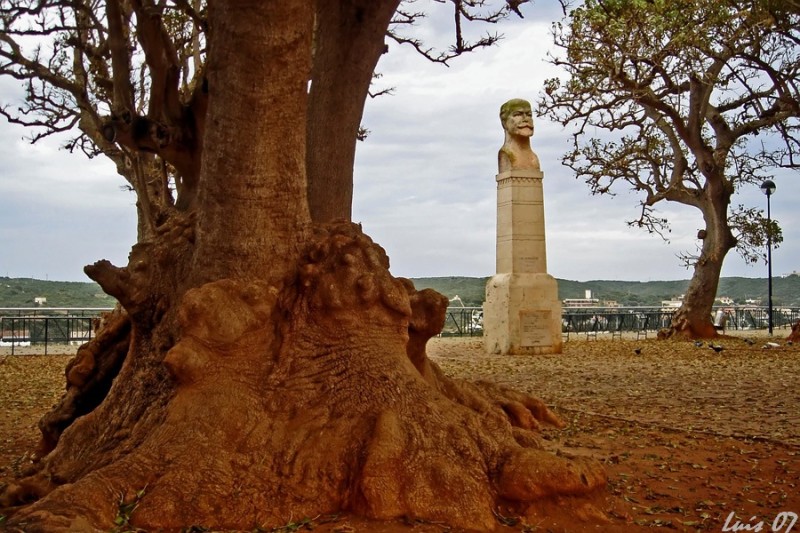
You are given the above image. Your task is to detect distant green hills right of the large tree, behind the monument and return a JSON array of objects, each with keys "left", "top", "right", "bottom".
[{"left": 413, "top": 276, "right": 800, "bottom": 307}]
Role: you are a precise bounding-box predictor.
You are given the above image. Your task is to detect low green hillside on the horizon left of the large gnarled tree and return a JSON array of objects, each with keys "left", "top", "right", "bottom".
[{"left": 0, "top": 276, "right": 117, "bottom": 307}]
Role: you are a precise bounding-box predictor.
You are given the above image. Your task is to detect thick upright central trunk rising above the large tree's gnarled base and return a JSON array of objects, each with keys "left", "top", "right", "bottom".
[{"left": 192, "top": 0, "right": 314, "bottom": 285}]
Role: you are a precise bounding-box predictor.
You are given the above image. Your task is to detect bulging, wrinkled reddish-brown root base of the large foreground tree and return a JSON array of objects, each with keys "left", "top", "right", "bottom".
[{"left": 1, "top": 225, "right": 606, "bottom": 532}]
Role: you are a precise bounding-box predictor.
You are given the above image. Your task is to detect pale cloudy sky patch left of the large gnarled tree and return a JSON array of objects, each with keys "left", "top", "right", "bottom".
[{"left": 0, "top": 123, "right": 136, "bottom": 281}]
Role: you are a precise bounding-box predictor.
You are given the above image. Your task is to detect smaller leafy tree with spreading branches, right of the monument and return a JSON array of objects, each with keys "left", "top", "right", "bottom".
[{"left": 538, "top": 0, "right": 800, "bottom": 338}]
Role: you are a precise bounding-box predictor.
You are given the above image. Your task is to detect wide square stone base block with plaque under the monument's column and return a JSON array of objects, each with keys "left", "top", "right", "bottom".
[{"left": 483, "top": 273, "right": 562, "bottom": 355}]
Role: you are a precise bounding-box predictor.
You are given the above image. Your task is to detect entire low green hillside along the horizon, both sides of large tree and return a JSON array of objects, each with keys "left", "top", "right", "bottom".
[{"left": 0, "top": 276, "right": 800, "bottom": 307}]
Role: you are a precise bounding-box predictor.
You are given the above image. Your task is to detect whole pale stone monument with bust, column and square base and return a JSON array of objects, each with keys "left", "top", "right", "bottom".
[{"left": 483, "top": 99, "right": 562, "bottom": 355}]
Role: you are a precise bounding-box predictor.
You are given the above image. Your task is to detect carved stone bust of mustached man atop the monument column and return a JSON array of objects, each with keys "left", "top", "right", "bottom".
[{"left": 497, "top": 98, "right": 541, "bottom": 173}]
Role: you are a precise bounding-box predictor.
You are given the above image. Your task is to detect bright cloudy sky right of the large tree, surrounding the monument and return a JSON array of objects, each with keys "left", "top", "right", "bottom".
[{"left": 354, "top": 8, "right": 800, "bottom": 280}]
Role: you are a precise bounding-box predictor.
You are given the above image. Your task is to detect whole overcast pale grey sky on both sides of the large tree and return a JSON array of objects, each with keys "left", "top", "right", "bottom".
[{"left": 0, "top": 2, "right": 800, "bottom": 281}]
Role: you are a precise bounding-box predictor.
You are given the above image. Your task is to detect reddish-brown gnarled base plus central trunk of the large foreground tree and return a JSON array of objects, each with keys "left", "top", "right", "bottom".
[{"left": 2, "top": 0, "right": 606, "bottom": 533}]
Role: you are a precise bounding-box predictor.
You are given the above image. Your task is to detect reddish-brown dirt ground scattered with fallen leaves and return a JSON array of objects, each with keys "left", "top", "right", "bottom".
[{"left": 0, "top": 330, "right": 800, "bottom": 533}]
